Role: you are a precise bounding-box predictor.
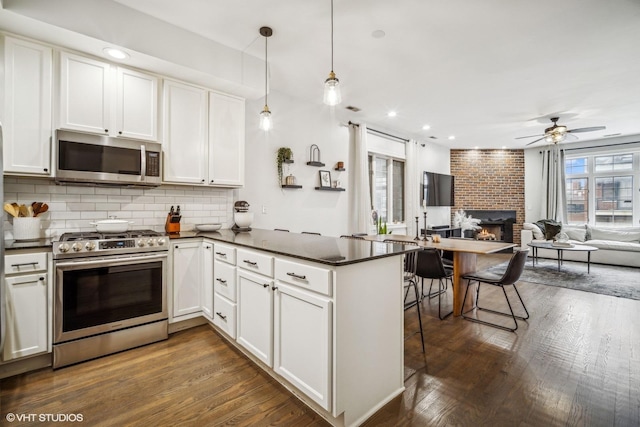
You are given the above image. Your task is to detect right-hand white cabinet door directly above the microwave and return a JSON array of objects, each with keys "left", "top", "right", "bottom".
[{"left": 116, "top": 67, "right": 158, "bottom": 141}]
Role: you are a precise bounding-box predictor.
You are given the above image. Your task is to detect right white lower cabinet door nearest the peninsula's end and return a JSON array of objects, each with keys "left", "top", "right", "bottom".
[{"left": 273, "top": 281, "right": 332, "bottom": 410}]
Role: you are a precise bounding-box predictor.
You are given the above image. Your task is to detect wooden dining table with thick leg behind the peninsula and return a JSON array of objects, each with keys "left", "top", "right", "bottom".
[{"left": 364, "top": 234, "right": 516, "bottom": 316}]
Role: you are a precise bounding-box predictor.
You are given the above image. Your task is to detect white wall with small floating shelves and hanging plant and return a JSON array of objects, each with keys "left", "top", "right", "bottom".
[{"left": 236, "top": 91, "right": 350, "bottom": 236}]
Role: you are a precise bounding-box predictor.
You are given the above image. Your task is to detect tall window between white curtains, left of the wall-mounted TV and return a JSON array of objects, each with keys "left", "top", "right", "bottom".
[{"left": 369, "top": 153, "right": 404, "bottom": 223}]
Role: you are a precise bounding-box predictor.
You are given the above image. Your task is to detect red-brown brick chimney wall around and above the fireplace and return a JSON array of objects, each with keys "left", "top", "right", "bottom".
[{"left": 451, "top": 150, "right": 524, "bottom": 245}]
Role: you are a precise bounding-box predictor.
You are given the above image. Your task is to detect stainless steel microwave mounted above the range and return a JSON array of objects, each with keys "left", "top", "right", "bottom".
[{"left": 55, "top": 130, "right": 162, "bottom": 187}]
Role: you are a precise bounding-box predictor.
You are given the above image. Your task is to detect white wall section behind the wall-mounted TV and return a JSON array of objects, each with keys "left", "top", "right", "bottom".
[{"left": 418, "top": 141, "right": 451, "bottom": 228}]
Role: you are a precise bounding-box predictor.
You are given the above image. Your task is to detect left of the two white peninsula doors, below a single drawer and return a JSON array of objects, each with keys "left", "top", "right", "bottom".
[{"left": 237, "top": 268, "right": 273, "bottom": 366}]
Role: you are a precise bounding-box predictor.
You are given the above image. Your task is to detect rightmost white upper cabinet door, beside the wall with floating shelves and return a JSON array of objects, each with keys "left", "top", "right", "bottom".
[{"left": 209, "top": 92, "right": 245, "bottom": 187}]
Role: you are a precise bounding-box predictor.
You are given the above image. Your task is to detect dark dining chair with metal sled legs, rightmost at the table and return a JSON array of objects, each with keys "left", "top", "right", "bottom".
[{"left": 462, "top": 249, "right": 529, "bottom": 332}]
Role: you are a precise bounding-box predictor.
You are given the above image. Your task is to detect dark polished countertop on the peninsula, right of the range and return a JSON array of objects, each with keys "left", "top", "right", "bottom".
[{"left": 169, "top": 228, "right": 418, "bottom": 266}]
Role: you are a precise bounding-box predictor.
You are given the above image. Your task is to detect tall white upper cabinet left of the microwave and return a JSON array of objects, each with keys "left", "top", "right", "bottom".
[{"left": 0, "top": 37, "right": 52, "bottom": 175}]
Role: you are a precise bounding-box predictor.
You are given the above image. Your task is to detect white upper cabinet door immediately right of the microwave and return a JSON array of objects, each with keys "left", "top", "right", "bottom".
[{"left": 162, "top": 80, "right": 208, "bottom": 184}]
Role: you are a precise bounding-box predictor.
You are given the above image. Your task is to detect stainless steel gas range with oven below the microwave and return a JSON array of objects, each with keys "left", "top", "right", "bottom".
[{"left": 53, "top": 230, "right": 169, "bottom": 368}]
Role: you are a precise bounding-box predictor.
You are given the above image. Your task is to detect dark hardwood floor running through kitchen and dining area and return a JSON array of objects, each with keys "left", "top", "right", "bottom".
[{"left": 0, "top": 254, "right": 640, "bottom": 426}]
